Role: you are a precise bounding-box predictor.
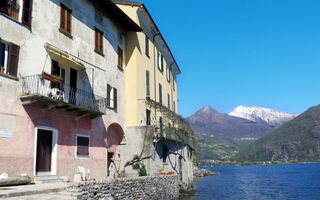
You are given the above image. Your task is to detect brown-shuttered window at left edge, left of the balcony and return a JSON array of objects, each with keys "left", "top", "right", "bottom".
[{"left": 0, "top": 39, "right": 20, "bottom": 77}]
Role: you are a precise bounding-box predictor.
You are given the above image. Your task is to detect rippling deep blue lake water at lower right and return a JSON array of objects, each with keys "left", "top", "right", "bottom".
[{"left": 183, "top": 163, "right": 320, "bottom": 200}]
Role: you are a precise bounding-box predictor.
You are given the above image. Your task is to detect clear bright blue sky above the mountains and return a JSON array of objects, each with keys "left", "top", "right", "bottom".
[{"left": 143, "top": 0, "right": 320, "bottom": 117}]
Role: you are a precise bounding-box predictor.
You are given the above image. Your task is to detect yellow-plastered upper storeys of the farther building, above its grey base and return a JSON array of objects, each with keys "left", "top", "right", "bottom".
[{"left": 114, "top": 1, "right": 181, "bottom": 127}]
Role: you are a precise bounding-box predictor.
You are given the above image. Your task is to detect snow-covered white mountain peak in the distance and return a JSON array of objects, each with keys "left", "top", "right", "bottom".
[{"left": 229, "top": 106, "right": 295, "bottom": 127}]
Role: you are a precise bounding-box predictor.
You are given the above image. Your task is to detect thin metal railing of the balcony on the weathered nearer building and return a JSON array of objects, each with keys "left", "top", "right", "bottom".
[{"left": 22, "top": 74, "right": 106, "bottom": 114}]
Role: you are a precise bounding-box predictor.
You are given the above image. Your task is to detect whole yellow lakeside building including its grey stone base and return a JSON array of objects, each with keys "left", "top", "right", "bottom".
[{"left": 113, "top": 0, "right": 193, "bottom": 188}]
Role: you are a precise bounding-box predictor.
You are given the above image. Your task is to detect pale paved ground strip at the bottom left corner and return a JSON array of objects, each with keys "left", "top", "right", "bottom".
[{"left": 0, "top": 192, "right": 77, "bottom": 200}]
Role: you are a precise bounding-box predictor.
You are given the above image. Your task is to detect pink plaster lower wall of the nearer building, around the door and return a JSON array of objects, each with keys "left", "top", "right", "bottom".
[{"left": 0, "top": 94, "right": 107, "bottom": 179}]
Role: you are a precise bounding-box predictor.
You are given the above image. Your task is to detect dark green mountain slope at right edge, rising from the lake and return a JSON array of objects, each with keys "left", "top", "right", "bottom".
[{"left": 238, "top": 105, "right": 320, "bottom": 162}]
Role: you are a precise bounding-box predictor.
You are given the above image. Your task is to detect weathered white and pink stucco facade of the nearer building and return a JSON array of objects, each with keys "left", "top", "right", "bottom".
[{"left": 0, "top": 0, "right": 139, "bottom": 179}]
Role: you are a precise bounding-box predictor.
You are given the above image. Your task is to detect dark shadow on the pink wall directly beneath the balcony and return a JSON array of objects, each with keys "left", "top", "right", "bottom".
[{"left": 24, "top": 102, "right": 107, "bottom": 148}]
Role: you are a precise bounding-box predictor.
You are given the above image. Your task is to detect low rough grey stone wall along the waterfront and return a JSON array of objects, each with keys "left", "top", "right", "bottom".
[{"left": 73, "top": 175, "right": 179, "bottom": 200}]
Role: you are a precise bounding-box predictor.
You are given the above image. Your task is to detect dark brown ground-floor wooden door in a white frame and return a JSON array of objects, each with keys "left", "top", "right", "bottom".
[{"left": 36, "top": 129, "right": 52, "bottom": 172}]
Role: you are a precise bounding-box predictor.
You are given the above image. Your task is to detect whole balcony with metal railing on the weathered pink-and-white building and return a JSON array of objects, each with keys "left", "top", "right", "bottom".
[{"left": 20, "top": 74, "right": 106, "bottom": 118}]
